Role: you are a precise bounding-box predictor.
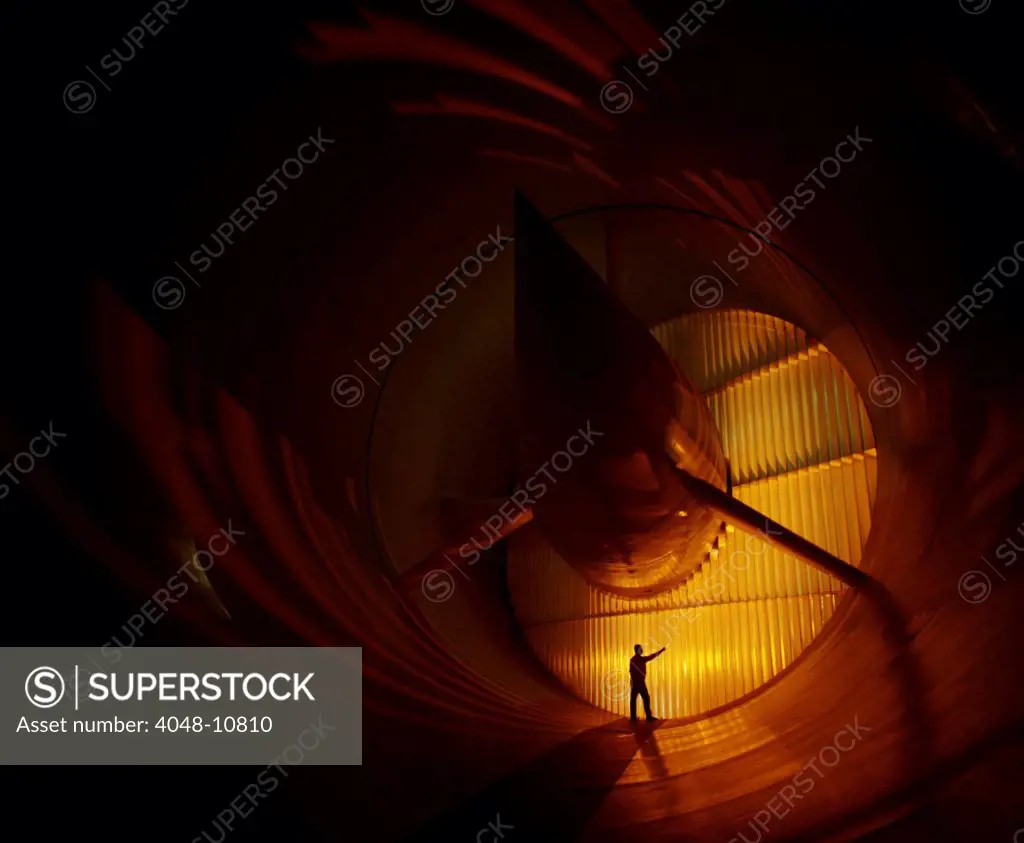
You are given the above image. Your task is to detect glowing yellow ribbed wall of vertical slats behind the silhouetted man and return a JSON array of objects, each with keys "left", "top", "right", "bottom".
[{"left": 509, "top": 311, "right": 878, "bottom": 717}]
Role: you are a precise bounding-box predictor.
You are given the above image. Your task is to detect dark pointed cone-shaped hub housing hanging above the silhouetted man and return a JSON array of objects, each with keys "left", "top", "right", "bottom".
[{"left": 515, "top": 196, "right": 726, "bottom": 597}]
